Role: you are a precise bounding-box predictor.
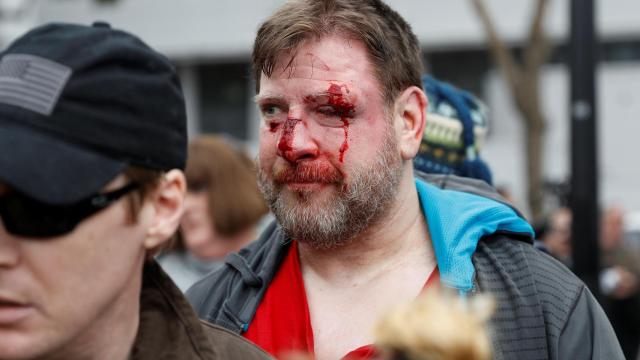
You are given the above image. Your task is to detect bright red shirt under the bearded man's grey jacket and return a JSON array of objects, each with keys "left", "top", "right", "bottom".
[{"left": 244, "top": 241, "right": 439, "bottom": 360}]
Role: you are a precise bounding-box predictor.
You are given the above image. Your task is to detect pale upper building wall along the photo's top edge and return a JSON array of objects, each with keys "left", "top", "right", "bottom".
[{"left": 31, "top": 0, "right": 640, "bottom": 60}]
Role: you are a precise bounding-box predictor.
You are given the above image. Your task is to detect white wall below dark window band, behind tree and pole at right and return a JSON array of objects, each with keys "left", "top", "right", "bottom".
[{"left": 482, "top": 63, "right": 640, "bottom": 215}]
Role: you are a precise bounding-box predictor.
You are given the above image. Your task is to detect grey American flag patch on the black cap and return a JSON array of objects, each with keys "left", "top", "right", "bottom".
[{"left": 0, "top": 54, "right": 72, "bottom": 115}]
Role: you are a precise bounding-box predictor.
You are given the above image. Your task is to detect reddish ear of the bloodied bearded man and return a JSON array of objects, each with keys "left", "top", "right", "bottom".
[{"left": 394, "top": 86, "right": 427, "bottom": 160}]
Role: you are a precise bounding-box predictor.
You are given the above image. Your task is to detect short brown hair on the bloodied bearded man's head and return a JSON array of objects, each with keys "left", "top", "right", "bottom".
[{"left": 252, "top": 0, "right": 423, "bottom": 105}]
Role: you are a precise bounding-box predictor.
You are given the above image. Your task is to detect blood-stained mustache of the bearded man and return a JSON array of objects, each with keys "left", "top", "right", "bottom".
[{"left": 273, "top": 162, "right": 343, "bottom": 184}]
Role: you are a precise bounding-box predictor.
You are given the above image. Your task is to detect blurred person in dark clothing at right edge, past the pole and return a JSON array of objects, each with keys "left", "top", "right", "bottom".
[{"left": 600, "top": 205, "right": 640, "bottom": 359}]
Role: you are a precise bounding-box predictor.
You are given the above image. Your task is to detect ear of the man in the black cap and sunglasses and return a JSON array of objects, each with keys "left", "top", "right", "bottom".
[{"left": 144, "top": 169, "right": 187, "bottom": 250}]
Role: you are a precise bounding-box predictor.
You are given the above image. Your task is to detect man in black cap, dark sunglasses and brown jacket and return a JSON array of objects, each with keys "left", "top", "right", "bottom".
[{"left": 0, "top": 23, "right": 268, "bottom": 359}]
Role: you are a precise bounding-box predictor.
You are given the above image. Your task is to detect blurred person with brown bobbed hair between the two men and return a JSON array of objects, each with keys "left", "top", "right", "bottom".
[{"left": 158, "top": 135, "right": 268, "bottom": 291}]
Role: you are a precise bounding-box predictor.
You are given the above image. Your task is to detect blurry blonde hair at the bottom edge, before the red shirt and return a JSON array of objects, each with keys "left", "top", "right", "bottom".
[{"left": 375, "top": 289, "right": 493, "bottom": 360}]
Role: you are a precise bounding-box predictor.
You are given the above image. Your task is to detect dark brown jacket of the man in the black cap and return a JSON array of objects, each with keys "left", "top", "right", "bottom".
[{"left": 129, "top": 260, "right": 271, "bottom": 360}]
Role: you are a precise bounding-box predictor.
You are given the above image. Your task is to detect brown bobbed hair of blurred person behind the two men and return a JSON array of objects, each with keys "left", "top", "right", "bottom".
[{"left": 185, "top": 135, "right": 267, "bottom": 236}]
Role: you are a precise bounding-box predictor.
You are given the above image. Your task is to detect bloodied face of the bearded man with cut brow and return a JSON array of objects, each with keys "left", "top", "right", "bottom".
[{"left": 257, "top": 36, "right": 402, "bottom": 248}]
